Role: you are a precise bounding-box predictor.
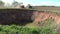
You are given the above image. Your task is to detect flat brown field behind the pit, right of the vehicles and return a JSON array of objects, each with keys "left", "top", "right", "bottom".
[{"left": 33, "top": 6, "right": 60, "bottom": 11}]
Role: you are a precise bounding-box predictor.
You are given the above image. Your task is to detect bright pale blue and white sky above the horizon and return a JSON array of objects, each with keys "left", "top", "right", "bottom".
[{"left": 2, "top": 0, "right": 60, "bottom": 6}]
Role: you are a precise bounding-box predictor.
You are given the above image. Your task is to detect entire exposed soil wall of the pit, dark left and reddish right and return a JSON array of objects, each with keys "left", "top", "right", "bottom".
[{"left": 0, "top": 9, "right": 60, "bottom": 25}]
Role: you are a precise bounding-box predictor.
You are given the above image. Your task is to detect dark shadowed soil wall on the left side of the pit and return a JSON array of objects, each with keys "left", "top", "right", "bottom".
[{"left": 0, "top": 9, "right": 36, "bottom": 25}]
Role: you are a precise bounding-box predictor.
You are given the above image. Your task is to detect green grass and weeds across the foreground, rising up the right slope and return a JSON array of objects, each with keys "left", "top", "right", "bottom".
[{"left": 0, "top": 19, "right": 60, "bottom": 34}]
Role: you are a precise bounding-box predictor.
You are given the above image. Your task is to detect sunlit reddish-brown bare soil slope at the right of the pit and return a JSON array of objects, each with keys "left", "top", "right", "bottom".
[{"left": 34, "top": 12, "right": 60, "bottom": 25}]
